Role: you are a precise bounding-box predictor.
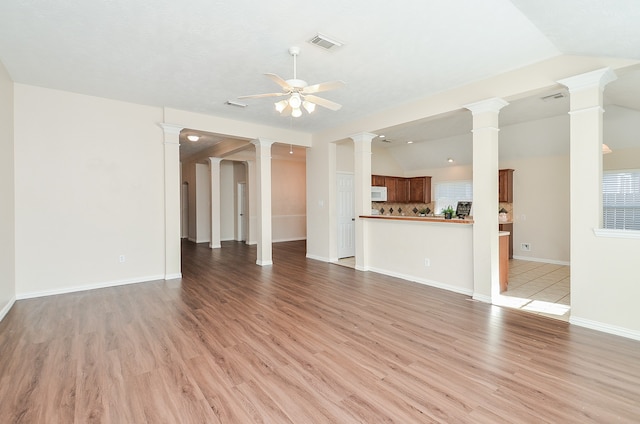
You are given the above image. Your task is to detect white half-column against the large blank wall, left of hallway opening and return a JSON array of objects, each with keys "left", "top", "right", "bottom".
[{"left": 160, "top": 124, "right": 182, "bottom": 280}]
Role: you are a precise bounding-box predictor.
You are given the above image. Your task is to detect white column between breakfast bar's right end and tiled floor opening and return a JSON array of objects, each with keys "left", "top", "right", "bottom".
[{"left": 465, "top": 98, "right": 509, "bottom": 302}]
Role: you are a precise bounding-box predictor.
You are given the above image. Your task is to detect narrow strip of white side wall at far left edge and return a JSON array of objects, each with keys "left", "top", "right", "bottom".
[{"left": 0, "top": 58, "right": 16, "bottom": 320}]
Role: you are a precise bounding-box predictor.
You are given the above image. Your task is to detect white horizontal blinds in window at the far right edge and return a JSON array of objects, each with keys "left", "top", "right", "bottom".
[{"left": 602, "top": 170, "right": 640, "bottom": 230}]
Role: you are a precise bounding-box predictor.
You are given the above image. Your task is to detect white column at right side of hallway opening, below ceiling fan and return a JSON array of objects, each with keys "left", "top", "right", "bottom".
[{"left": 252, "top": 138, "right": 273, "bottom": 266}]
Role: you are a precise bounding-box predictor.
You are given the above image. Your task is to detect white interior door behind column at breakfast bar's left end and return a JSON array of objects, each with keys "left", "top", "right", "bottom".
[{"left": 336, "top": 173, "right": 356, "bottom": 259}]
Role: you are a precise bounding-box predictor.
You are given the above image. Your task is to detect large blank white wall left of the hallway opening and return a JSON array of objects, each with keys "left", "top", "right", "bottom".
[{"left": 15, "top": 84, "right": 164, "bottom": 297}]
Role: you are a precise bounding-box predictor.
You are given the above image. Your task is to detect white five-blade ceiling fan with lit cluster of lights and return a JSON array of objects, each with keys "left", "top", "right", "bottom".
[{"left": 238, "top": 47, "right": 345, "bottom": 118}]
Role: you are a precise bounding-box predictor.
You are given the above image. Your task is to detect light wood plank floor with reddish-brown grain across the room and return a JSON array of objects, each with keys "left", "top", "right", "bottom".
[{"left": 0, "top": 242, "right": 640, "bottom": 424}]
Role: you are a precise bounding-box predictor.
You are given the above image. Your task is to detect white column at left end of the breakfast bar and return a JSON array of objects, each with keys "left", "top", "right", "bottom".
[{"left": 350, "top": 132, "right": 376, "bottom": 271}]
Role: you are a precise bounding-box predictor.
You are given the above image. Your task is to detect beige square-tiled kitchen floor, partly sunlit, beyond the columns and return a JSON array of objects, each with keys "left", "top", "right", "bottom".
[{"left": 336, "top": 257, "right": 571, "bottom": 321}]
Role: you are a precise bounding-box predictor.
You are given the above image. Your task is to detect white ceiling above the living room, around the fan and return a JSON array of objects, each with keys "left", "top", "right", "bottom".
[{"left": 0, "top": 0, "right": 640, "bottom": 161}]
